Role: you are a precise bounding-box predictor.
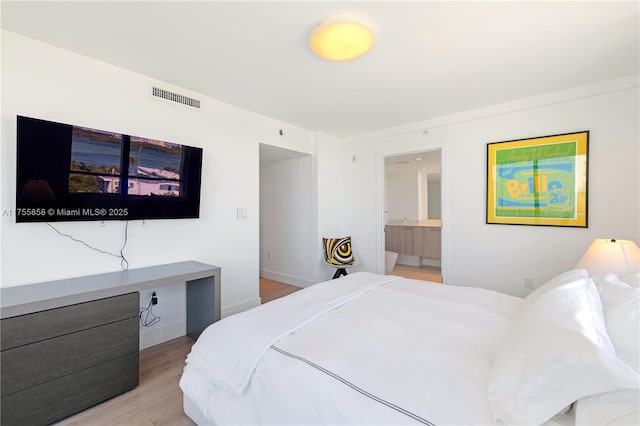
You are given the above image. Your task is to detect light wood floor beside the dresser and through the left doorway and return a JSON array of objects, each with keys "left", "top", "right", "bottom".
[{"left": 58, "top": 278, "right": 300, "bottom": 426}]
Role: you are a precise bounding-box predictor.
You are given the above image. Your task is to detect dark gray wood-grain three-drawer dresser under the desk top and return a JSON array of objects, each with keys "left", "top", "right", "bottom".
[{"left": 0, "top": 292, "right": 139, "bottom": 426}]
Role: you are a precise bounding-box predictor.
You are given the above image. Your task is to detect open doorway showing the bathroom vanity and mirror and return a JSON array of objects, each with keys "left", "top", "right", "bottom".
[{"left": 383, "top": 149, "right": 442, "bottom": 282}]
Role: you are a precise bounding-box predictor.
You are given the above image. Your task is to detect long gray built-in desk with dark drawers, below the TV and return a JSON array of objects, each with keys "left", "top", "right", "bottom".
[{"left": 0, "top": 262, "right": 221, "bottom": 425}]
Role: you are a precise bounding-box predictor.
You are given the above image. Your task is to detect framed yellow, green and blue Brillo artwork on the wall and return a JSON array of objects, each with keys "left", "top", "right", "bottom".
[{"left": 487, "top": 131, "right": 589, "bottom": 228}]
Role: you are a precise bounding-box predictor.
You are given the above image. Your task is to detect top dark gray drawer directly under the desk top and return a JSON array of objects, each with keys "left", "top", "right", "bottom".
[{"left": 0, "top": 292, "right": 140, "bottom": 356}]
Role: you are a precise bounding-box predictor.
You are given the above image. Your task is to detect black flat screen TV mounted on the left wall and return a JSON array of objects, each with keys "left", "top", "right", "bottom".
[{"left": 16, "top": 116, "right": 202, "bottom": 222}]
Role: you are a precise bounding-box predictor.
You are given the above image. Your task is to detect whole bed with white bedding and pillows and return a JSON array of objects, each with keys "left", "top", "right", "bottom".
[{"left": 180, "top": 270, "right": 640, "bottom": 426}]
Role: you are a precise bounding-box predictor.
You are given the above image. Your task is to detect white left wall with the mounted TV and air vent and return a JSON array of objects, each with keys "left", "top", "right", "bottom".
[{"left": 0, "top": 30, "right": 314, "bottom": 348}]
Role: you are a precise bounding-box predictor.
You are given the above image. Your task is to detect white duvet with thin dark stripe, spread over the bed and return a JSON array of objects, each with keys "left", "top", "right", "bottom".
[{"left": 180, "top": 272, "right": 522, "bottom": 425}]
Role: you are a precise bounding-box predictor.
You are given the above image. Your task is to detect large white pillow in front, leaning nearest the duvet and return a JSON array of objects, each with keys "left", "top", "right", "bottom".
[{"left": 489, "top": 271, "right": 638, "bottom": 424}]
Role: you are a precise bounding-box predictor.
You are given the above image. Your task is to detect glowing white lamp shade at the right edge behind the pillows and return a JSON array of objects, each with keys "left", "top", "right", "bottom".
[{"left": 576, "top": 239, "right": 640, "bottom": 277}]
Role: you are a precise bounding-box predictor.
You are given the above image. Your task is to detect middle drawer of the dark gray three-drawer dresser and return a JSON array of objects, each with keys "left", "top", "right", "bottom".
[{"left": 0, "top": 317, "right": 140, "bottom": 397}]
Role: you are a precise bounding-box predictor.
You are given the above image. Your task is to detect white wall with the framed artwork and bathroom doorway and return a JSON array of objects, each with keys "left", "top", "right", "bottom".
[{"left": 343, "top": 75, "right": 640, "bottom": 295}]
